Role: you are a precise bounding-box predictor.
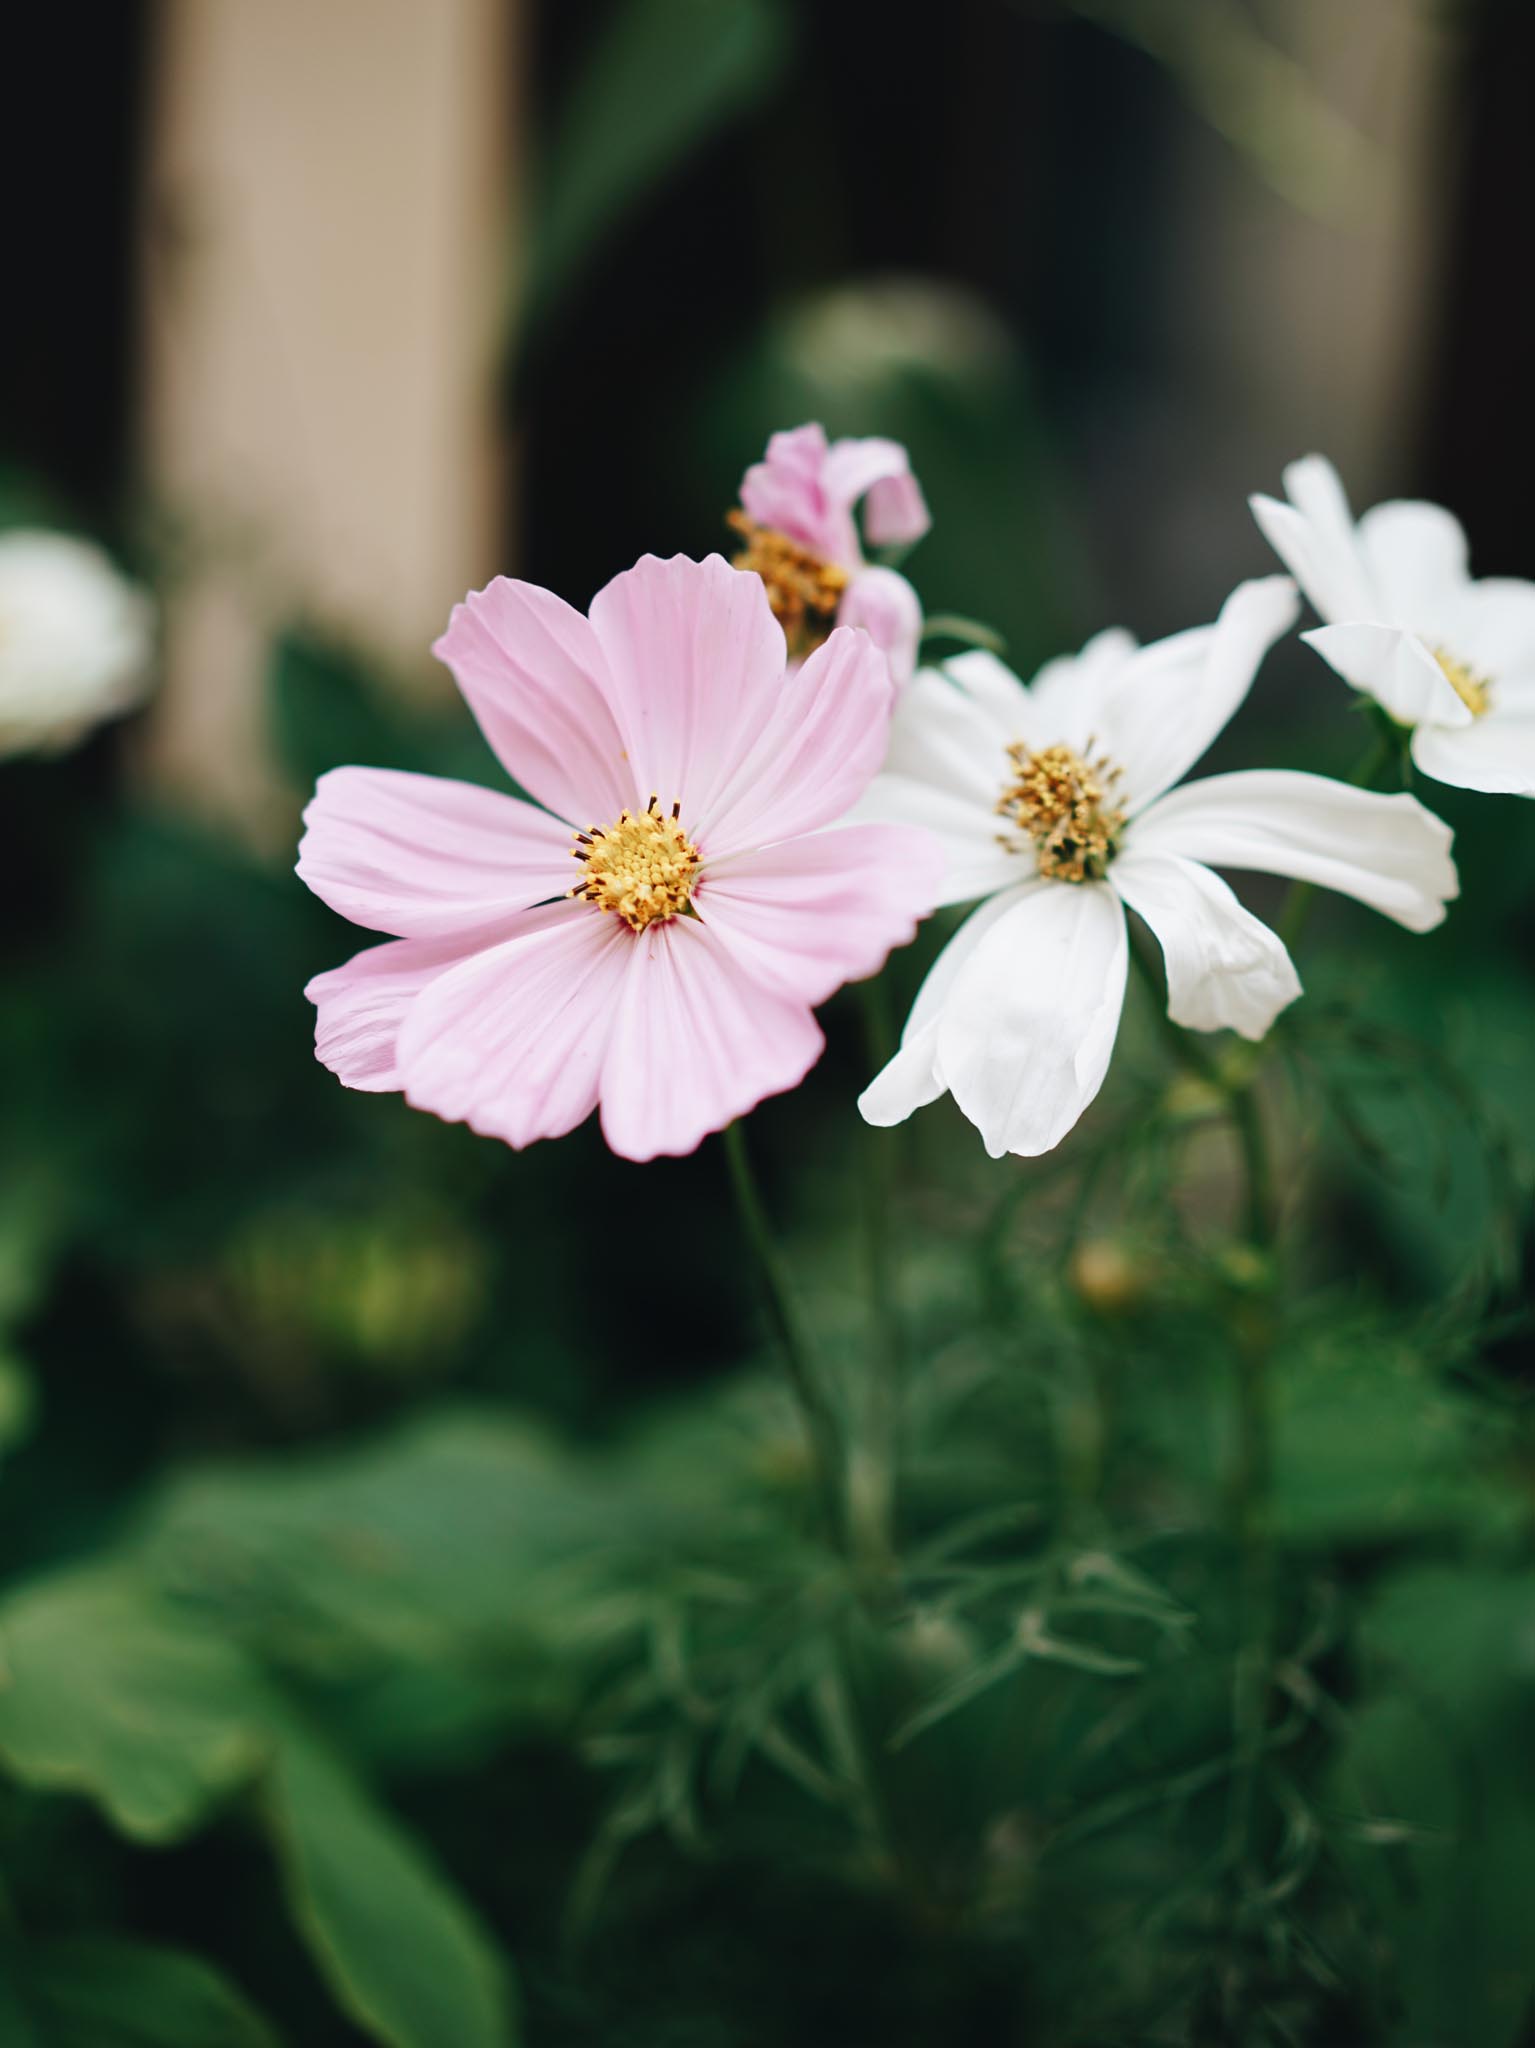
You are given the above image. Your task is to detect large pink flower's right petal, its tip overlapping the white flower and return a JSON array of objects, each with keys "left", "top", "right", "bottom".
[{"left": 694, "top": 825, "right": 944, "bottom": 1004}]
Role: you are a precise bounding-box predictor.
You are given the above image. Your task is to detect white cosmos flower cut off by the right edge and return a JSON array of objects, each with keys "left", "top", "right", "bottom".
[{"left": 1253, "top": 455, "right": 1535, "bottom": 797}]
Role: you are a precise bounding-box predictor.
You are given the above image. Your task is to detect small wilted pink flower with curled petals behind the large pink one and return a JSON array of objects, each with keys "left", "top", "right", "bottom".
[{"left": 731, "top": 424, "right": 931, "bottom": 684}]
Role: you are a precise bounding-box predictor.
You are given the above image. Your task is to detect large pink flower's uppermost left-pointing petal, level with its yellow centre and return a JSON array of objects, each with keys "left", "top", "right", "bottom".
[{"left": 299, "top": 768, "right": 575, "bottom": 938}]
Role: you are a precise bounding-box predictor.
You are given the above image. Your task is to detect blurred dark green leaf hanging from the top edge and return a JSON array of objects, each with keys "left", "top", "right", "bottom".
[{"left": 526, "top": 0, "right": 790, "bottom": 322}]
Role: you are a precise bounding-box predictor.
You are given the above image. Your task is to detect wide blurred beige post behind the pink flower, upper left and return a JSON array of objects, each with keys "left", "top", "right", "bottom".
[{"left": 143, "top": 0, "right": 516, "bottom": 834}]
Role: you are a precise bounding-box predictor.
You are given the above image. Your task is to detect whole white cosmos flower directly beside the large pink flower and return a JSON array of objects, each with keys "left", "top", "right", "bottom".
[{"left": 858, "top": 575, "right": 1457, "bottom": 1157}]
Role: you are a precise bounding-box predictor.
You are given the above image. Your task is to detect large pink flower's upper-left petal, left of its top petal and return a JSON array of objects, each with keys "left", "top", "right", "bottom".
[{"left": 432, "top": 575, "right": 630, "bottom": 825}]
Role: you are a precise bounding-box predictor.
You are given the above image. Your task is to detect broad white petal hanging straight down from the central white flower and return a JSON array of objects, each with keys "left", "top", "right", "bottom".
[{"left": 937, "top": 883, "right": 1128, "bottom": 1159}]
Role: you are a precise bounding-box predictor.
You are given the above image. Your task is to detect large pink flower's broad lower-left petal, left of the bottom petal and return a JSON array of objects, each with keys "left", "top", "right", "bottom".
[{"left": 399, "top": 903, "right": 634, "bottom": 1147}]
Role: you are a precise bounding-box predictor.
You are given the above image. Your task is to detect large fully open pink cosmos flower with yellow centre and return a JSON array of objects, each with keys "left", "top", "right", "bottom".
[{"left": 299, "top": 555, "right": 941, "bottom": 1159}]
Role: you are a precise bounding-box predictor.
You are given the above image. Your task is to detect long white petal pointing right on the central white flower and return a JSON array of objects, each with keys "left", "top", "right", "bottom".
[{"left": 1126, "top": 768, "right": 1459, "bottom": 932}]
